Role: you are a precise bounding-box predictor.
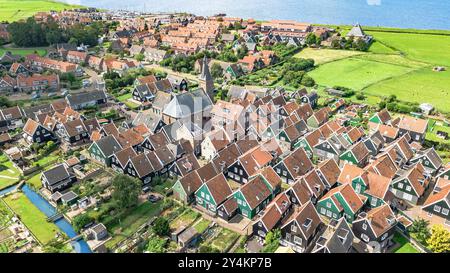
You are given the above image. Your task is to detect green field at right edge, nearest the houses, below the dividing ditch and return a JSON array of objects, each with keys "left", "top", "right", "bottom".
[{"left": 364, "top": 67, "right": 450, "bottom": 112}]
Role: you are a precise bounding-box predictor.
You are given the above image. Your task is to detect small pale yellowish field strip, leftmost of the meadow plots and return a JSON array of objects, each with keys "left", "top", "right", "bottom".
[{"left": 294, "top": 48, "right": 366, "bottom": 65}]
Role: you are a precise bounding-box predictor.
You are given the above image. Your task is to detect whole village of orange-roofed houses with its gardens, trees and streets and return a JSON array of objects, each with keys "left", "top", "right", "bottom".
[{"left": 0, "top": 9, "right": 450, "bottom": 253}]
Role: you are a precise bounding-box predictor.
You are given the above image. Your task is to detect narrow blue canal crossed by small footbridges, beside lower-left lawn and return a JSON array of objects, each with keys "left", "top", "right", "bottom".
[{"left": 17, "top": 185, "right": 91, "bottom": 253}]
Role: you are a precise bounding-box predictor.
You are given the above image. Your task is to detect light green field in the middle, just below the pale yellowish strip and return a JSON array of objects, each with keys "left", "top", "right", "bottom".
[{"left": 309, "top": 57, "right": 413, "bottom": 91}]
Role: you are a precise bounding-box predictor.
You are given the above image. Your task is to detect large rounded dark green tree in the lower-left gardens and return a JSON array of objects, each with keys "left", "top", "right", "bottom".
[{"left": 112, "top": 174, "right": 141, "bottom": 208}]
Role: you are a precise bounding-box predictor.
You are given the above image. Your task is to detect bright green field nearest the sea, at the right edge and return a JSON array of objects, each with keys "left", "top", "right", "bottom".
[{"left": 367, "top": 31, "right": 450, "bottom": 66}]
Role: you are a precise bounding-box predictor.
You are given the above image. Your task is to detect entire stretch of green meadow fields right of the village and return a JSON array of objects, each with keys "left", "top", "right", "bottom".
[{"left": 296, "top": 28, "right": 450, "bottom": 112}]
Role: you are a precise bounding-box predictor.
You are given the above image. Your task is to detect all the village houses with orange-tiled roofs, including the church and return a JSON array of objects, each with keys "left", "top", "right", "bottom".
[{"left": 0, "top": 11, "right": 450, "bottom": 253}]
